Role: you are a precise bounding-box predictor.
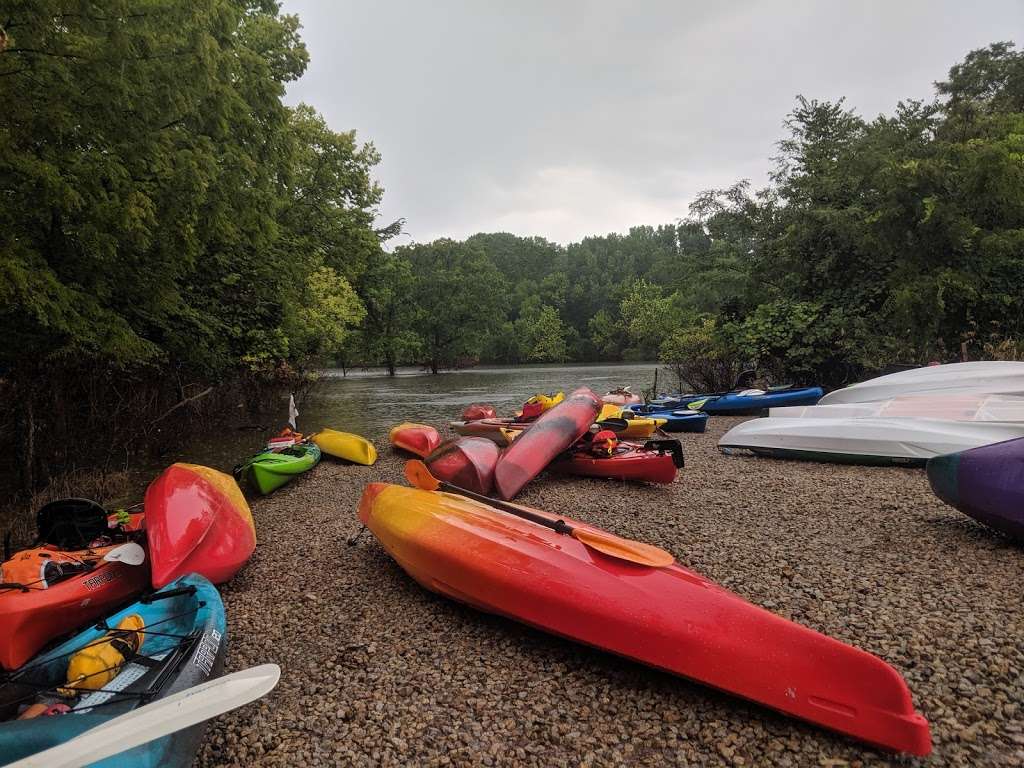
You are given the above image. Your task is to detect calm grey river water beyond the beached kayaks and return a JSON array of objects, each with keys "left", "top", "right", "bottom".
[{"left": 154, "top": 362, "right": 670, "bottom": 471}]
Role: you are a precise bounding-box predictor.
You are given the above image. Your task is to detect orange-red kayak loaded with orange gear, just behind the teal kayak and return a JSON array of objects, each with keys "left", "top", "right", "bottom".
[{"left": 0, "top": 515, "right": 150, "bottom": 672}]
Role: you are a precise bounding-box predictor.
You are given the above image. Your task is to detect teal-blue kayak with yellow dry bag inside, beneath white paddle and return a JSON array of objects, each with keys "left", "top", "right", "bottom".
[{"left": 0, "top": 573, "right": 227, "bottom": 768}]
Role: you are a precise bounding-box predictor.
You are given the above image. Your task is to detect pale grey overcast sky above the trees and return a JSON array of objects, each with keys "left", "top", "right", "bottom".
[{"left": 284, "top": 0, "right": 1024, "bottom": 243}]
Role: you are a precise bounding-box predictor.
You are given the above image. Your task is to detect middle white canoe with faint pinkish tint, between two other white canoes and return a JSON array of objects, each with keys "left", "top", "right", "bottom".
[{"left": 768, "top": 393, "right": 1024, "bottom": 422}]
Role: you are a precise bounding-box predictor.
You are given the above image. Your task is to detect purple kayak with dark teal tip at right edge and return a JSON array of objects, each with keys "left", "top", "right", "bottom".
[{"left": 928, "top": 437, "right": 1024, "bottom": 542}]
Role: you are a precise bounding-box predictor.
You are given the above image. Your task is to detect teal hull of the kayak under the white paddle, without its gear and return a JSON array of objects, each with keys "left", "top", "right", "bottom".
[{"left": 0, "top": 574, "right": 227, "bottom": 768}]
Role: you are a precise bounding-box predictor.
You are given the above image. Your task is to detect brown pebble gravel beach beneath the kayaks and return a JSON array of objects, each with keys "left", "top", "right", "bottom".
[{"left": 198, "top": 415, "right": 1024, "bottom": 768}]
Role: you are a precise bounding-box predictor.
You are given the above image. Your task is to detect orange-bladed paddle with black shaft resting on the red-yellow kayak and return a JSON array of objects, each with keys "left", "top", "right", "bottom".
[{"left": 406, "top": 459, "right": 675, "bottom": 568}]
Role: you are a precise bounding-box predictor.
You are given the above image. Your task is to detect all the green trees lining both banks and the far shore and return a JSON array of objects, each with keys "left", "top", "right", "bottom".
[{"left": 0, "top": 0, "right": 1024, "bottom": 488}]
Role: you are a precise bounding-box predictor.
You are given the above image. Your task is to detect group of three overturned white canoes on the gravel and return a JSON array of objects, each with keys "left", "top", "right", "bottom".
[{"left": 719, "top": 362, "right": 1024, "bottom": 466}]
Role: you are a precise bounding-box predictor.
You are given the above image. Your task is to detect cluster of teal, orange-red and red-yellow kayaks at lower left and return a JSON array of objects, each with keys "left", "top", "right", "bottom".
[{"left": 0, "top": 464, "right": 272, "bottom": 767}]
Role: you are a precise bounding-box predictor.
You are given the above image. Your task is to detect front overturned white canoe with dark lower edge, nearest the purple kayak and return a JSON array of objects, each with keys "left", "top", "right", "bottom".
[{"left": 718, "top": 417, "right": 1024, "bottom": 465}]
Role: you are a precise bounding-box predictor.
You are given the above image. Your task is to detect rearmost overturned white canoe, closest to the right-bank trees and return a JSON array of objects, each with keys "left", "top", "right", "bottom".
[{"left": 818, "top": 360, "right": 1024, "bottom": 406}]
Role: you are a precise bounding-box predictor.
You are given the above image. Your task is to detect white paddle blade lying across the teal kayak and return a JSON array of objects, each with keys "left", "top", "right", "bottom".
[{"left": 8, "top": 664, "right": 281, "bottom": 768}]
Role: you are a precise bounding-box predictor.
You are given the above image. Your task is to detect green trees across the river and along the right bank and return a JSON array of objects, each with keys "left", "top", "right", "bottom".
[{"left": 362, "top": 42, "right": 1024, "bottom": 389}]
